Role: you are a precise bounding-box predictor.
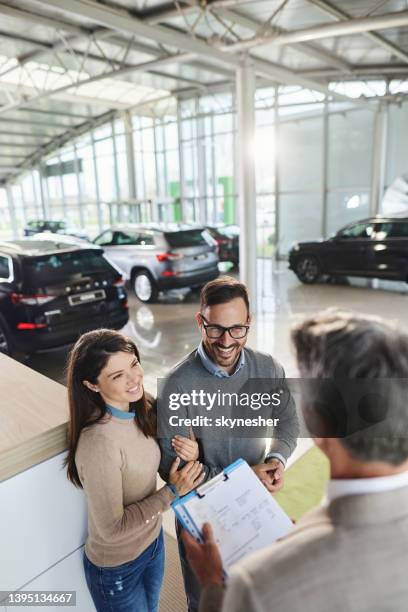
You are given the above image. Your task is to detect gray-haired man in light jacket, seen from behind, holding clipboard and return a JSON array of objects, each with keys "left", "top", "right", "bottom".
[{"left": 183, "top": 311, "right": 408, "bottom": 612}]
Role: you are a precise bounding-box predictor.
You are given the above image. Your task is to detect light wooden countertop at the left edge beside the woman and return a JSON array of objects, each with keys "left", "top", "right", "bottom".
[{"left": 0, "top": 353, "right": 68, "bottom": 482}]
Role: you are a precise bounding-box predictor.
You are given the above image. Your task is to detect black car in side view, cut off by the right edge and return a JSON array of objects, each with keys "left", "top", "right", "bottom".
[{"left": 289, "top": 217, "right": 408, "bottom": 283}]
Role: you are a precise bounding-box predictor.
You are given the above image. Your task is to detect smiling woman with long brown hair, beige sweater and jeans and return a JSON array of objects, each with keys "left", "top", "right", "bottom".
[{"left": 66, "top": 329, "right": 203, "bottom": 612}]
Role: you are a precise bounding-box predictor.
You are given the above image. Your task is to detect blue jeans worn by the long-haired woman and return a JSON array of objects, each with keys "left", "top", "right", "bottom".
[{"left": 84, "top": 530, "right": 164, "bottom": 612}]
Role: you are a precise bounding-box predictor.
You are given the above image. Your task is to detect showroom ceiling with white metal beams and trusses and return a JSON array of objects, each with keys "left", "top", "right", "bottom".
[{"left": 0, "top": 0, "right": 408, "bottom": 183}]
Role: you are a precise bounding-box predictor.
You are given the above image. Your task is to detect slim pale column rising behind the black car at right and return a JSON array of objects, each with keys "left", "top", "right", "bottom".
[{"left": 370, "top": 104, "right": 388, "bottom": 216}]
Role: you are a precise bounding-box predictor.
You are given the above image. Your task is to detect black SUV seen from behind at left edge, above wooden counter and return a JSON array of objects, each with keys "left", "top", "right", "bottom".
[{"left": 0, "top": 238, "right": 129, "bottom": 355}]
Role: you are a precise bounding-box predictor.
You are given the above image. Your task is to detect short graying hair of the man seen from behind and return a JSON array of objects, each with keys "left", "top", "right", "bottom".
[{"left": 292, "top": 310, "right": 408, "bottom": 465}]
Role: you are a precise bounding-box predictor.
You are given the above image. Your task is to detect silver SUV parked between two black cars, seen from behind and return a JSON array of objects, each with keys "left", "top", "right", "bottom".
[{"left": 94, "top": 225, "right": 219, "bottom": 302}]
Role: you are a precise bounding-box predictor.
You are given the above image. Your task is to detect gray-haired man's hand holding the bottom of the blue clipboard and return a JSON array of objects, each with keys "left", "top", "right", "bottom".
[{"left": 181, "top": 523, "right": 224, "bottom": 587}]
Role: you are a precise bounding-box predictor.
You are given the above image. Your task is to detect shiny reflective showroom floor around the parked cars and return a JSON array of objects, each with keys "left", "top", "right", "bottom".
[{"left": 27, "top": 261, "right": 408, "bottom": 392}]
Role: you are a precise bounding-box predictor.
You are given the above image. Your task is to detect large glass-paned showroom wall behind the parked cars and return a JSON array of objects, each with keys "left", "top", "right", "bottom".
[{"left": 0, "top": 86, "right": 408, "bottom": 257}]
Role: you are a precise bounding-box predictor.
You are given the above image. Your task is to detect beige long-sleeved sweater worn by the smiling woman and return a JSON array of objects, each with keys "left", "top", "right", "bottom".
[{"left": 75, "top": 416, "right": 174, "bottom": 567}]
